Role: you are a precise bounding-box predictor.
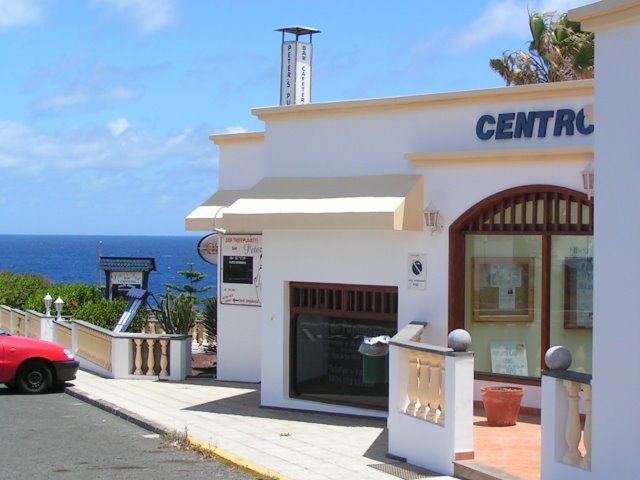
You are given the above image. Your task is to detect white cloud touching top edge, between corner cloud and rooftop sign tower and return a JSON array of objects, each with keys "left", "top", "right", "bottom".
[{"left": 99, "top": 0, "right": 177, "bottom": 33}]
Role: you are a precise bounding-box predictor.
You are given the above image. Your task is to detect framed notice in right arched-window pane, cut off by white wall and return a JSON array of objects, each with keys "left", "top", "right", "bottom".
[{"left": 564, "top": 257, "right": 593, "bottom": 328}]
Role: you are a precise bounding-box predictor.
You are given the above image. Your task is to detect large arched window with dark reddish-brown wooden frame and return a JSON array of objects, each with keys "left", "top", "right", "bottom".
[{"left": 449, "top": 185, "right": 593, "bottom": 384}]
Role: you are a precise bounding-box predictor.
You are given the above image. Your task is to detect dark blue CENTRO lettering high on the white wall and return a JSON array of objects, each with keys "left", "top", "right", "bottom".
[{"left": 476, "top": 108, "right": 593, "bottom": 140}]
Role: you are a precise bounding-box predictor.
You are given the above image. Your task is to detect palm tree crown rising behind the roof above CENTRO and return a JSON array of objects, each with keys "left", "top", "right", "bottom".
[{"left": 489, "top": 12, "right": 594, "bottom": 85}]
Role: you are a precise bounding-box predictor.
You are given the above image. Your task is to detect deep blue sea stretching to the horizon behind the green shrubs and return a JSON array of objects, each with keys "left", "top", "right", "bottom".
[{"left": 0, "top": 235, "right": 217, "bottom": 296}]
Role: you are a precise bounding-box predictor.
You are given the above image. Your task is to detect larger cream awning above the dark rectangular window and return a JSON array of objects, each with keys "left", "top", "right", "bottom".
[{"left": 208, "top": 175, "right": 424, "bottom": 232}]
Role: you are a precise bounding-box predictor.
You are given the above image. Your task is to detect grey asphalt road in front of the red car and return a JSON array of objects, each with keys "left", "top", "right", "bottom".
[{"left": 0, "top": 386, "right": 255, "bottom": 480}]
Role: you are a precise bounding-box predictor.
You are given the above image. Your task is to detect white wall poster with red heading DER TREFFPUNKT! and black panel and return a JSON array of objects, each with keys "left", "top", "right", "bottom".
[{"left": 220, "top": 234, "right": 262, "bottom": 307}]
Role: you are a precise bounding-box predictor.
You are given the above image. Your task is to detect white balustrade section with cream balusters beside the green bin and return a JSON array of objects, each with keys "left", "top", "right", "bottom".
[{"left": 387, "top": 323, "right": 473, "bottom": 475}]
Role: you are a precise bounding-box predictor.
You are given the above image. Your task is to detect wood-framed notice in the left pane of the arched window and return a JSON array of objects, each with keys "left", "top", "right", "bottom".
[{"left": 471, "top": 257, "right": 534, "bottom": 322}]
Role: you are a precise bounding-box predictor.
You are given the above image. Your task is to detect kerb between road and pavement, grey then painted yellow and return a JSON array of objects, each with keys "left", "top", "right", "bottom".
[{"left": 64, "top": 387, "right": 288, "bottom": 480}]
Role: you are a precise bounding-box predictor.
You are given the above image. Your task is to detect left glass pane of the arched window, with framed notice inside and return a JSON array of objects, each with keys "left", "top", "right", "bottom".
[{"left": 465, "top": 235, "right": 542, "bottom": 377}]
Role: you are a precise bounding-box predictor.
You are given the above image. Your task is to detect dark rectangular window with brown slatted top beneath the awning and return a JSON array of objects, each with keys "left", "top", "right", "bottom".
[{"left": 290, "top": 283, "right": 398, "bottom": 410}]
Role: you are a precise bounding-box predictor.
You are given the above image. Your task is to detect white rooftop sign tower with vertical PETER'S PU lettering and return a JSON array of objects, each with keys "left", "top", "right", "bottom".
[{"left": 280, "top": 41, "right": 312, "bottom": 105}]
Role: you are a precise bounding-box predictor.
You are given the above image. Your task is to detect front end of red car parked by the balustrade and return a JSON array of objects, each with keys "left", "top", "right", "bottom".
[{"left": 0, "top": 330, "right": 80, "bottom": 393}]
